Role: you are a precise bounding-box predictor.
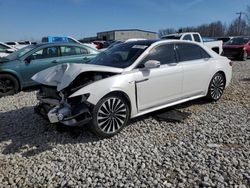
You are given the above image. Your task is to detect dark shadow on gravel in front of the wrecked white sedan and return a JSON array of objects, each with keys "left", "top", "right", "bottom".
[{"left": 0, "top": 107, "right": 99, "bottom": 157}]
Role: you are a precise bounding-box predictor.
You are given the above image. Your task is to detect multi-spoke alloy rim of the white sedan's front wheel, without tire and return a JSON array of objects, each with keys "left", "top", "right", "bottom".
[{"left": 97, "top": 97, "right": 128, "bottom": 134}]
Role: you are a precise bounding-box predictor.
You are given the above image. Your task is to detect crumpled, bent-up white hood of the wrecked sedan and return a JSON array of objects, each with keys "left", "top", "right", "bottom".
[{"left": 31, "top": 63, "right": 123, "bottom": 91}]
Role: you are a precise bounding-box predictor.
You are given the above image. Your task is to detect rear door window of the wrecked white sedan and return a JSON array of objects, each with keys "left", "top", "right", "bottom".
[{"left": 176, "top": 43, "right": 210, "bottom": 62}]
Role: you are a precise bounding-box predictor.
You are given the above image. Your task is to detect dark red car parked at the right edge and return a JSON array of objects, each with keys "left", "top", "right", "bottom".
[{"left": 223, "top": 37, "right": 250, "bottom": 61}]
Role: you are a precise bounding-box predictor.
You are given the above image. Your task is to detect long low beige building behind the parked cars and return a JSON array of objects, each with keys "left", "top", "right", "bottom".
[{"left": 80, "top": 29, "right": 157, "bottom": 42}]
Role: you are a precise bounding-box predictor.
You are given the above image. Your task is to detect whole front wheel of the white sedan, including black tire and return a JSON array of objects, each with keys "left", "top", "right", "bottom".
[{"left": 90, "top": 94, "right": 130, "bottom": 138}]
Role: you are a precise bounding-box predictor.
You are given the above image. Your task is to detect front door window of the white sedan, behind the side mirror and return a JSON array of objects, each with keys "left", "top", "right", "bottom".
[{"left": 143, "top": 44, "right": 177, "bottom": 65}]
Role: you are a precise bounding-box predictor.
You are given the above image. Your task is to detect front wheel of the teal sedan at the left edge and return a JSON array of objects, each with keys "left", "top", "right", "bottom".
[{"left": 0, "top": 74, "right": 19, "bottom": 97}]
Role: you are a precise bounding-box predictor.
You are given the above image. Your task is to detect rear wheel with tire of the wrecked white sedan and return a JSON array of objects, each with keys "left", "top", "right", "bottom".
[{"left": 207, "top": 73, "right": 226, "bottom": 101}]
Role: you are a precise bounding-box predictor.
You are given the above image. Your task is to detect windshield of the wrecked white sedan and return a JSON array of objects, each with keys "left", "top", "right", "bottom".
[{"left": 89, "top": 43, "right": 149, "bottom": 68}]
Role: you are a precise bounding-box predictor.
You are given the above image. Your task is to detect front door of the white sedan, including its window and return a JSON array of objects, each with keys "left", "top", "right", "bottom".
[{"left": 135, "top": 43, "right": 183, "bottom": 111}]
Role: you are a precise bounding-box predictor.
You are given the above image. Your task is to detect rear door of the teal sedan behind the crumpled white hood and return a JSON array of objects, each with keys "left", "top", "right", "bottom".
[{"left": 59, "top": 46, "right": 96, "bottom": 63}]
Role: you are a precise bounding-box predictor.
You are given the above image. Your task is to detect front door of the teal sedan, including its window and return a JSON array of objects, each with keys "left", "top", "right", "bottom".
[{"left": 20, "top": 46, "right": 59, "bottom": 85}]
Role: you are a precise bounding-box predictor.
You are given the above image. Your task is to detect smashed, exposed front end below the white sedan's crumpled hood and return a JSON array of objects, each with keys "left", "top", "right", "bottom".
[{"left": 35, "top": 86, "right": 93, "bottom": 126}]
